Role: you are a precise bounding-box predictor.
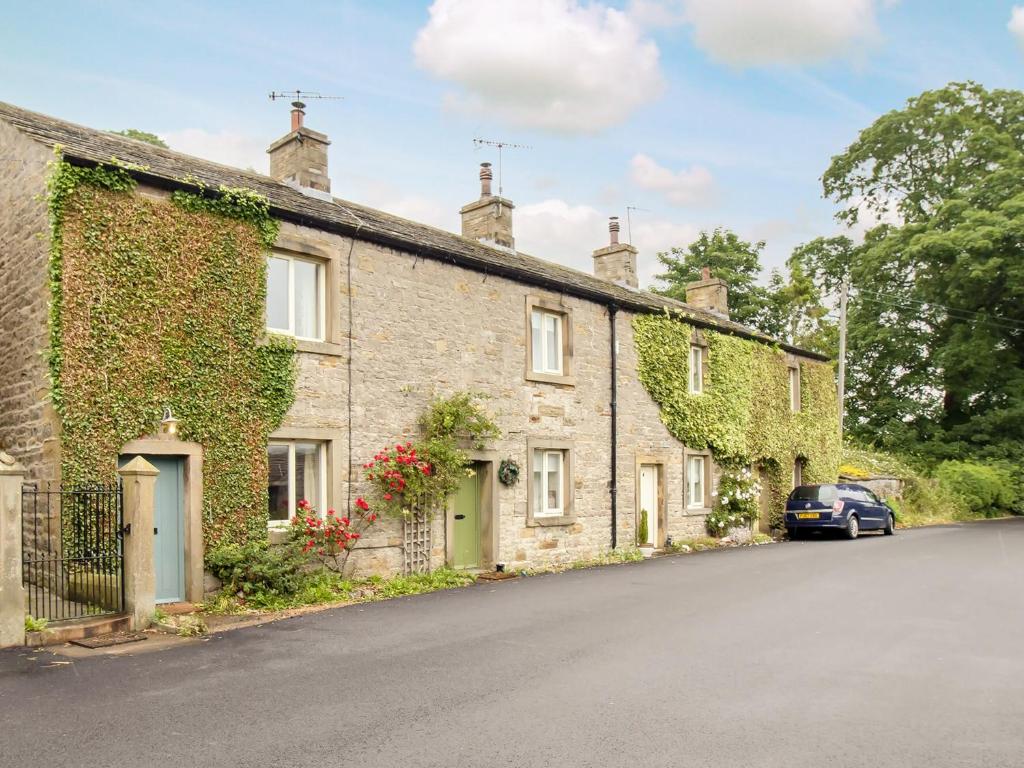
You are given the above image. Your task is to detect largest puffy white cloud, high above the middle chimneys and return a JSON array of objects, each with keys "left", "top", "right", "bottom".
[{"left": 414, "top": 0, "right": 664, "bottom": 134}]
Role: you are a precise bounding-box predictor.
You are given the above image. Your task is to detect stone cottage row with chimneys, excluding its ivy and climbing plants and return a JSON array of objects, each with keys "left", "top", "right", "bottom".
[{"left": 0, "top": 104, "right": 835, "bottom": 600}]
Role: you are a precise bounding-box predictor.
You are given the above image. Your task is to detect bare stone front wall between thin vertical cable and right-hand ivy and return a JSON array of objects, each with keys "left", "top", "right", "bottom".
[{"left": 342, "top": 236, "right": 720, "bottom": 571}]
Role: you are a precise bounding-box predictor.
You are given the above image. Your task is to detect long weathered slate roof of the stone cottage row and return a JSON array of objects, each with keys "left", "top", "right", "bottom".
[{"left": 0, "top": 101, "right": 827, "bottom": 359}]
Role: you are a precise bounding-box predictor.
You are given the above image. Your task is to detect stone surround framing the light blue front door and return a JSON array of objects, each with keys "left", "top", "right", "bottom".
[{"left": 121, "top": 437, "right": 203, "bottom": 603}]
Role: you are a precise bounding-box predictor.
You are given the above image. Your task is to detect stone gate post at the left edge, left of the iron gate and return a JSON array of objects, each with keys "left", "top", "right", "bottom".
[{"left": 0, "top": 451, "right": 25, "bottom": 648}]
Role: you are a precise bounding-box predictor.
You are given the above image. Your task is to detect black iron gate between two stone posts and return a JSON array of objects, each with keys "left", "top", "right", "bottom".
[{"left": 22, "top": 483, "right": 124, "bottom": 622}]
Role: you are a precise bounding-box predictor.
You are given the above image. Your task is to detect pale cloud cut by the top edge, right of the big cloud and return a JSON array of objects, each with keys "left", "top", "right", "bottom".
[{"left": 631, "top": 0, "right": 895, "bottom": 67}]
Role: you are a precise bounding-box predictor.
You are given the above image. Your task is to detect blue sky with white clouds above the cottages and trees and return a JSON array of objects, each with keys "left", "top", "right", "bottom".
[{"left": 6, "top": 0, "right": 1024, "bottom": 286}]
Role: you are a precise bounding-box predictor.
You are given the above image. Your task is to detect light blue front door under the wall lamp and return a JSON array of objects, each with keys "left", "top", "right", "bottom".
[{"left": 121, "top": 456, "right": 185, "bottom": 603}]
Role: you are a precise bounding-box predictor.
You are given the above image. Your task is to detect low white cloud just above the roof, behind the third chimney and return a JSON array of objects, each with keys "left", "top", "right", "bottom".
[{"left": 514, "top": 199, "right": 698, "bottom": 288}]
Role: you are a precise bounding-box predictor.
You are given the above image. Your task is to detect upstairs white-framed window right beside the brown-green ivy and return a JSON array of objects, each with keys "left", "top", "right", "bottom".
[{"left": 266, "top": 253, "right": 327, "bottom": 341}]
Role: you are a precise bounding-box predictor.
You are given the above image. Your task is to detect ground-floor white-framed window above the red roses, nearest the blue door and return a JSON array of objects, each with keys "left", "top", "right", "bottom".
[{"left": 266, "top": 440, "right": 327, "bottom": 527}]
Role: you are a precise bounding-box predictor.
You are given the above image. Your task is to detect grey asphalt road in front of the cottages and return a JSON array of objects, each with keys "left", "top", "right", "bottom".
[{"left": 0, "top": 519, "right": 1024, "bottom": 768}]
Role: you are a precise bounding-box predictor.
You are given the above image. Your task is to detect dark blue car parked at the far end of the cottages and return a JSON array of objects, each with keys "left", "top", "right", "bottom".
[{"left": 785, "top": 482, "right": 896, "bottom": 539}]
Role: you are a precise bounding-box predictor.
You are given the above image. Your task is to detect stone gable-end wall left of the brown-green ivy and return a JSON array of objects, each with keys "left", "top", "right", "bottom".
[{"left": 0, "top": 121, "right": 60, "bottom": 480}]
